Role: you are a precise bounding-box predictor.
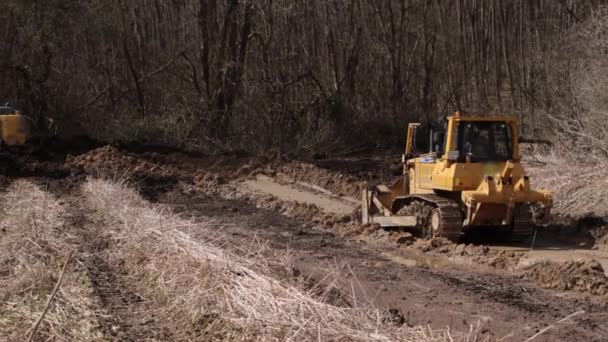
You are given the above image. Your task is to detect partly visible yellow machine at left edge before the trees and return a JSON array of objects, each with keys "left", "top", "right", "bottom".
[{"left": 0, "top": 106, "right": 32, "bottom": 146}]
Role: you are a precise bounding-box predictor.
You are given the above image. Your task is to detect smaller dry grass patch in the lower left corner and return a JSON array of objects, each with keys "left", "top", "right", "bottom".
[{"left": 0, "top": 181, "right": 100, "bottom": 341}]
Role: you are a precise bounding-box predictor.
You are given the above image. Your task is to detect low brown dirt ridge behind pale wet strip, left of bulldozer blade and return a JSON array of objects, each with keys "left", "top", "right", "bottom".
[{"left": 276, "top": 161, "right": 364, "bottom": 198}]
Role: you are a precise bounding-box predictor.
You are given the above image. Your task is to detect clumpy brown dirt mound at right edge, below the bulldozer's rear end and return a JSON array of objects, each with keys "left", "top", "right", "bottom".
[{"left": 526, "top": 260, "right": 608, "bottom": 296}]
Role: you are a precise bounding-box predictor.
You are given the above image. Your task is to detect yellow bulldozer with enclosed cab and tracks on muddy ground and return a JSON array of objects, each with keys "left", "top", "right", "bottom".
[{"left": 362, "top": 112, "right": 553, "bottom": 242}]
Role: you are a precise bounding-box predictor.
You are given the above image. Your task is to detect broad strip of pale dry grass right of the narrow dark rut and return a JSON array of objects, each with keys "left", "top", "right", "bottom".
[{"left": 83, "top": 179, "right": 476, "bottom": 341}]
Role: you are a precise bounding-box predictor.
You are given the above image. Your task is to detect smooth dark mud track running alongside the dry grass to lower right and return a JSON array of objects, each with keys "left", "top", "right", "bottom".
[{"left": 159, "top": 187, "right": 608, "bottom": 341}]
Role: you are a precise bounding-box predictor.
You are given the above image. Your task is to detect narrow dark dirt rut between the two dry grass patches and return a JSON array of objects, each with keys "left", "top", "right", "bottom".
[{"left": 34, "top": 177, "right": 171, "bottom": 341}]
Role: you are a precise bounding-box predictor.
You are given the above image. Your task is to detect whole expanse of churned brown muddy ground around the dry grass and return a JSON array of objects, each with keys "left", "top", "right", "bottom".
[{"left": 8, "top": 147, "right": 608, "bottom": 341}]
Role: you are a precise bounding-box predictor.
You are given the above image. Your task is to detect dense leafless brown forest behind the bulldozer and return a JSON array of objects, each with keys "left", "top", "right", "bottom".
[{"left": 0, "top": 0, "right": 608, "bottom": 157}]
